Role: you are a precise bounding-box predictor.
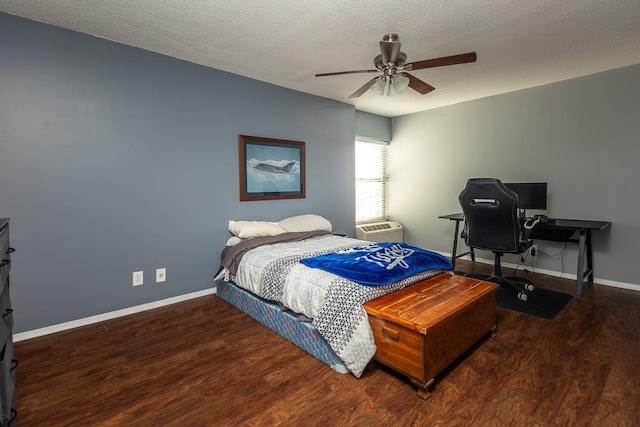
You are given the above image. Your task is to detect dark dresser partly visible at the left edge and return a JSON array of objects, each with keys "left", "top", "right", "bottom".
[{"left": 0, "top": 218, "right": 18, "bottom": 427}]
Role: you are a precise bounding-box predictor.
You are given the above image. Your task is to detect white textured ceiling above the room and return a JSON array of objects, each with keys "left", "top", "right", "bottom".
[{"left": 0, "top": 0, "right": 640, "bottom": 117}]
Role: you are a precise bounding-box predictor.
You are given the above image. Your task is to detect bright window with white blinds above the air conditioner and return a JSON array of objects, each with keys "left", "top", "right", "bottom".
[{"left": 356, "top": 139, "right": 387, "bottom": 223}]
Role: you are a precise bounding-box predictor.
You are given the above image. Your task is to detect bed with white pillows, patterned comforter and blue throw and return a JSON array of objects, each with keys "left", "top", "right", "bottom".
[{"left": 214, "top": 215, "right": 452, "bottom": 377}]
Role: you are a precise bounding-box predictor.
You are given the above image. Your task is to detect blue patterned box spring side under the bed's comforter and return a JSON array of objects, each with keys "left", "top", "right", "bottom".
[{"left": 216, "top": 281, "right": 349, "bottom": 374}]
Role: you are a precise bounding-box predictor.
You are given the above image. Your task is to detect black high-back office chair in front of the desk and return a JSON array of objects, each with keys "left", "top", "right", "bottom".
[{"left": 458, "top": 178, "right": 533, "bottom": 301}]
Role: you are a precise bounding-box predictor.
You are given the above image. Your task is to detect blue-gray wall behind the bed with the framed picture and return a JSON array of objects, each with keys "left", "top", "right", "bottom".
[{"left": 0, "top": 14, "right": 355, "bottom": 332}]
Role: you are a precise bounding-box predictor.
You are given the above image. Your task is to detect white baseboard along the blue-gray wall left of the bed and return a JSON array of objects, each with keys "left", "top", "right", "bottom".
[{"left": 13, "top": 288, "right": 217, "bottom": 342}]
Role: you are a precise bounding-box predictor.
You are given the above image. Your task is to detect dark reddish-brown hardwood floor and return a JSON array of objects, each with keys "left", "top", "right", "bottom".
[{"left": 15, "top": 261, "right": 640, "bottom": 427}]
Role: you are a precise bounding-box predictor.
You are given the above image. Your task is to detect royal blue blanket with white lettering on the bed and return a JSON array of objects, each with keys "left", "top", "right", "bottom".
[{"left": 300, "top": 242, "right": 453, "bottom": 286}]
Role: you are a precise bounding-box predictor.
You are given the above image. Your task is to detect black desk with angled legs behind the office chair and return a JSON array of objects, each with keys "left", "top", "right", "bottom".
[{"left": 438, "top": 213, "right": 611, "bottom": 297}]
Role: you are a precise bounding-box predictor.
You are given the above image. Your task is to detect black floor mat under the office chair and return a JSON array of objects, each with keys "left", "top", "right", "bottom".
[{"left": 496, "top": 287, "right": 573, "bottom": 319}]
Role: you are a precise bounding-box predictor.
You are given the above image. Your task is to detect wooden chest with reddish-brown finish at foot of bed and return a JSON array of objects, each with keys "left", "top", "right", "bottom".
[{"left": 364, "top": 274, "right": 498, "bottom": 399}]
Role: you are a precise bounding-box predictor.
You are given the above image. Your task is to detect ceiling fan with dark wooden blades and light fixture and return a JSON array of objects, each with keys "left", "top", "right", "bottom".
[{"left": 316, "top": 34, "right": 476, "bottom": 98}]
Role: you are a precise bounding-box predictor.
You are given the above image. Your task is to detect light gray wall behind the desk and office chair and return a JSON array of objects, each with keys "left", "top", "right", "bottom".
[{"left": 389, "top": 65, "right": 640, "bottom": 285}]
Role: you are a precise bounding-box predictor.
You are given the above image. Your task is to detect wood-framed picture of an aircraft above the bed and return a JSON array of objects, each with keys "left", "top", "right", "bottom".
[{"left": 238, "top": 135, "right": 306, "bottom": 201}]
